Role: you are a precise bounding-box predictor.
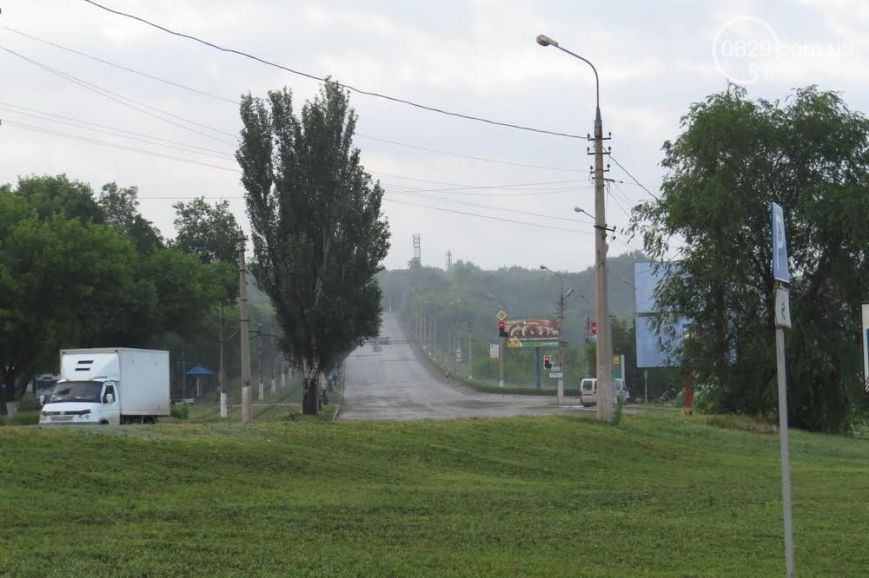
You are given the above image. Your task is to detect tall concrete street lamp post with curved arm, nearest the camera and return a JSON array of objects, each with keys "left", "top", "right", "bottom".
[{"left": 537, "top": 34, "right": 614, "bottom": 421}]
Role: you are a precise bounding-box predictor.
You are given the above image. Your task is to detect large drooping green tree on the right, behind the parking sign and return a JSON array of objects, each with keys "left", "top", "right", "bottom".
[{"left": 633, "top": 87, "right": 869, "bottom": 431}]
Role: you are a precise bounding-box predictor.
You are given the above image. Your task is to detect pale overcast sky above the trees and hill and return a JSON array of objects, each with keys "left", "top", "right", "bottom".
[{"left": 0, "top": 0, "right": 869, "bottom": 271}]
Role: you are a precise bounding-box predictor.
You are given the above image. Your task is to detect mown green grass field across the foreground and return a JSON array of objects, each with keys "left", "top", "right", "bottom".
[{"left": 0, "top": 408, "right": 869, "bottom": 576}]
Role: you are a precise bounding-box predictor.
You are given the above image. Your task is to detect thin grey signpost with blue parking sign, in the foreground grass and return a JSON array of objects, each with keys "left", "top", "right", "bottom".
[{"left": 771, "top": 203, "right": 796, "bottom": 578}]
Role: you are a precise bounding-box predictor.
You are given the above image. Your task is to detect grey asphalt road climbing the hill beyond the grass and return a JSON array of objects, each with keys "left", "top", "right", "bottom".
[{"left": 339, "top": 313, "right": 594, "bottom": 420}]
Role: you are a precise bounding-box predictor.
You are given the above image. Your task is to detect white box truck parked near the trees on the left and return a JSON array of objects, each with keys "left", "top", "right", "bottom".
[{"left": 39, "top": 347, "right": 169, "bottom": 425}]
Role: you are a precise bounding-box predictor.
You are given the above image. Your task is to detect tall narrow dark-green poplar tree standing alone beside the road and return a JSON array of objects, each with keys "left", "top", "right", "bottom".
[{"left": 236, "top": 82, "right": 389, "bottom": 414}]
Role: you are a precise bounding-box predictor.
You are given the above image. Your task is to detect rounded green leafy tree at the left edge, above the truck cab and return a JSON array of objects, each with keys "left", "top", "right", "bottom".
[{"left": 0, "top": 187, "right": 135, "bottom": 402}]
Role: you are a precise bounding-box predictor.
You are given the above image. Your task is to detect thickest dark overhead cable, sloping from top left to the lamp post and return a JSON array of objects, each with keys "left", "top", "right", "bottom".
[{"left": 84, "top": 0, "right": 586, "bottom": 140}]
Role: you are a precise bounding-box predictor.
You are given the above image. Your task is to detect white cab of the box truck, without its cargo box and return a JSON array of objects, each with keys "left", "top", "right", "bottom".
[{"left": 39, "top": 379, "right": 121, "bottom": 425}]
